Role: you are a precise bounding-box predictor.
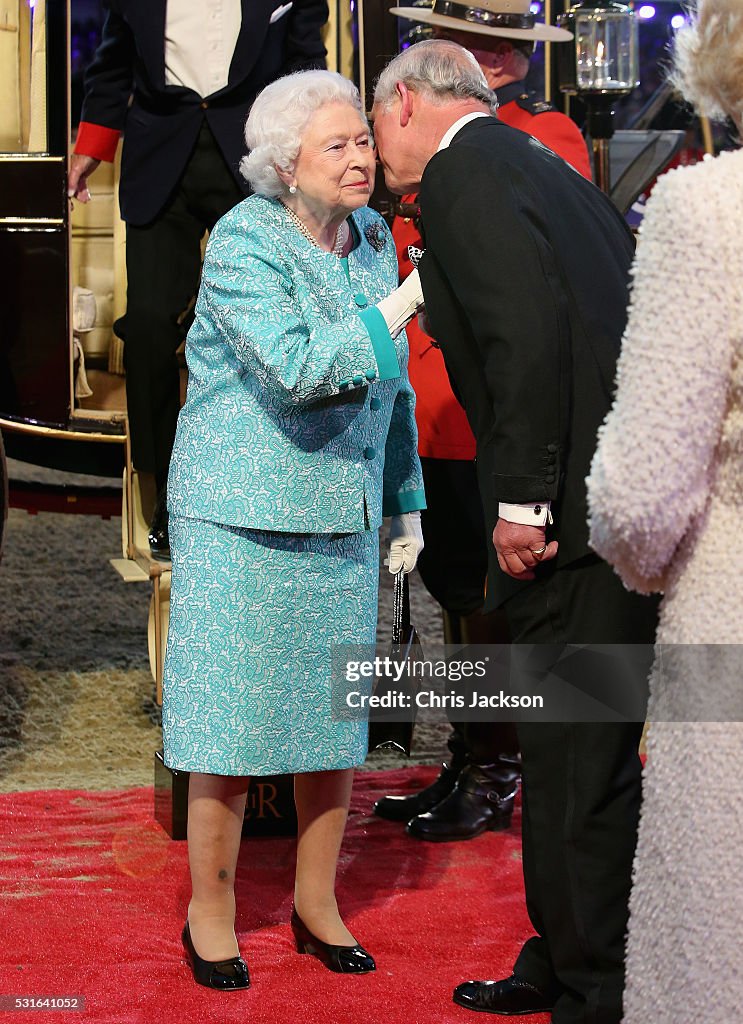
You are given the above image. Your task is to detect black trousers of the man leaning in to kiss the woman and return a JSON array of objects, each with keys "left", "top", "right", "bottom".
[{"left": 504, "top": 556, "right": 657, "bottom": 1024}]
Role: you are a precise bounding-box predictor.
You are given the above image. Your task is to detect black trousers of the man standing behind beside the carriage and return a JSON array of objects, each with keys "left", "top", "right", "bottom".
[{"left": 122, "top": 121, "right": 244, "bottom": 487}]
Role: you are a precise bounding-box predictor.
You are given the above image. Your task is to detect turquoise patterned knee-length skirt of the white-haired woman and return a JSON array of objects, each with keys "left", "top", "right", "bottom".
[{"left": 163, "top": 515, "right": 379, "bottom": 775}]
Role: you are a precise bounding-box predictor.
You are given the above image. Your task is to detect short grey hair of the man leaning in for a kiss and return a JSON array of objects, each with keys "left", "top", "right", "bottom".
[{"left": 375, "top": 39, "right": 497, "bottom": 114}]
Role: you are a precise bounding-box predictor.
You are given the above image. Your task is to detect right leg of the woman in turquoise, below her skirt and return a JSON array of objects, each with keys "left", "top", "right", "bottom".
[{"left": 294, "top": 768, "right": 356, "bottom": 946}]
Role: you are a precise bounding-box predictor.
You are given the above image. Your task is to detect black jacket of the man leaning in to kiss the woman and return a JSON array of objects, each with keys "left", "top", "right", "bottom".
[{"left": 420, "top": 117, "right": 633, "bottom": 606}]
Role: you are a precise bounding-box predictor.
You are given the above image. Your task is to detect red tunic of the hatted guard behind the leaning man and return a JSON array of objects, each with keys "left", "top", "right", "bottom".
[{"left": 392, "top": 94, "right": 592, "bottom": 459}]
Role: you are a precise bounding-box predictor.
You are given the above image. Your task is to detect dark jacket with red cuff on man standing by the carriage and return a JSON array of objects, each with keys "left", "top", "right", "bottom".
[{"left": 82, "top": 0, "right": 327, "bottom": 224}]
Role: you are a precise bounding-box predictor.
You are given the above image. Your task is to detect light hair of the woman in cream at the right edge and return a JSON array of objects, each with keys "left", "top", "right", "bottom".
[{"left": 669, "top": 0, "right": 743, "bottom": 130}]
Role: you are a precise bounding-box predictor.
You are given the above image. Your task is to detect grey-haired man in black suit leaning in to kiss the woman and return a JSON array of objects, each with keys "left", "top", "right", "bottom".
[{"left": 373, "top": 36, "right": 655, "bottom": 1024}]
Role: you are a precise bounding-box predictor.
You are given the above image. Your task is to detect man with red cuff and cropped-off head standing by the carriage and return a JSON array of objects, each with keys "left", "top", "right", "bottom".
[{"left": 69, "top": 0, "right": 327, "bottom": 560}]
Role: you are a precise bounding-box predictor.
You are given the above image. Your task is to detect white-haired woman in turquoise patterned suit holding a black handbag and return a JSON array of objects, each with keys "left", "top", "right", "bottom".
[{"left": 163, "top": 71, "right": 425, "bottom": 989}]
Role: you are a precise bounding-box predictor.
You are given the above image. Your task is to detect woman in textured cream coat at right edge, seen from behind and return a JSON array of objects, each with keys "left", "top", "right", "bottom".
[{"left": 588, "top": 0, "right": 743, "bottom": 1024}]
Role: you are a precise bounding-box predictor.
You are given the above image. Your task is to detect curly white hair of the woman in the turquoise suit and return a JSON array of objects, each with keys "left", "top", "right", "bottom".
[{"left": 239, "top": 71, "right": 366, "bottom": 198}]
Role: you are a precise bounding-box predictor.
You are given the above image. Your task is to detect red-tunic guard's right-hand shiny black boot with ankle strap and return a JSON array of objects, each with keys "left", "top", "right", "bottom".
[{"left": 405, "top": 762, "right": 521, "bottom": 843}]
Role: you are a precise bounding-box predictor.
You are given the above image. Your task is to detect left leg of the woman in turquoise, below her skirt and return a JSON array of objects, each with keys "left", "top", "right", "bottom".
[{"left": 188, "top": 772, "right": 250, "bottom": 961}]
